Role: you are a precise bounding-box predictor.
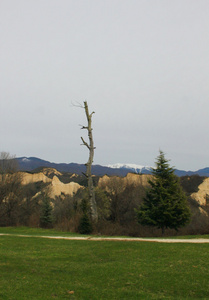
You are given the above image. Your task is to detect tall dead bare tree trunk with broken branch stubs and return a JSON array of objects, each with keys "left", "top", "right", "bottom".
[{"left": 81, "top": 101, "right": 98, "bottom": 221}]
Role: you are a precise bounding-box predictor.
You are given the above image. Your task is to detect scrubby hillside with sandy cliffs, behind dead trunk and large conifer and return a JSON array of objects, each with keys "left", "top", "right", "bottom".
[{"left": 0, "top": 163, "right": 209, "bottom": 236}]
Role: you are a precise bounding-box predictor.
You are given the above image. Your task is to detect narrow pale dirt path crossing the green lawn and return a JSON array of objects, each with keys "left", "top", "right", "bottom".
[{"left": 0, "top": 233, "right": 209, "bottom": 244}]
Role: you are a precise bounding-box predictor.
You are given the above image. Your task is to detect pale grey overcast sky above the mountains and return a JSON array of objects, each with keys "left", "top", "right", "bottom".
[{"left": 0, "top": 0, "right": 209, "bottom": 170}]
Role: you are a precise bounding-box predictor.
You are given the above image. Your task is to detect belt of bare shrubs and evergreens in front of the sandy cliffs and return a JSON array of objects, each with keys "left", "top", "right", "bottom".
[{"left": 0, "top": 152, "right": 209, "bottom": 236}]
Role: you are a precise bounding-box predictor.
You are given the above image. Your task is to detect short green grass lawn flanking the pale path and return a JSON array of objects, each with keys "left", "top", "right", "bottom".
[{"left": 0, "top": 228, "right": 209, "bottom": 300}]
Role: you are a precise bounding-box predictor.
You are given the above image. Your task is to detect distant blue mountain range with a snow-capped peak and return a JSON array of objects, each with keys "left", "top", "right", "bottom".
[{"left": 16, "top": 157, "right": 209, "bottom": 177}]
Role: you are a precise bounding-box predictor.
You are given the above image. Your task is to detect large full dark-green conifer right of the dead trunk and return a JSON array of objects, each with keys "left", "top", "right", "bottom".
[{"left": 137, "top": 151, "right": 191, "bottom": 234}]
